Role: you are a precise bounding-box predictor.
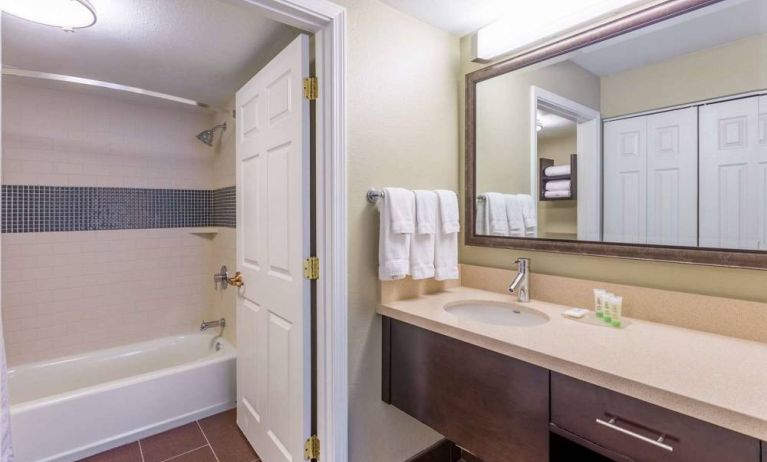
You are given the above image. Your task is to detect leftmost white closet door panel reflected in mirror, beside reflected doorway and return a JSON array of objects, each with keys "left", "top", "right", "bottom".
[{"left": 603, "top": 117, "right": 647, "bottom": 243}]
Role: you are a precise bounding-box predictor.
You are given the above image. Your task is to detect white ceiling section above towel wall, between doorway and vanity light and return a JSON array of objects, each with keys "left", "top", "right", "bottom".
[{"left": 383, "top": 0, "right": 514, "bottom": 36}]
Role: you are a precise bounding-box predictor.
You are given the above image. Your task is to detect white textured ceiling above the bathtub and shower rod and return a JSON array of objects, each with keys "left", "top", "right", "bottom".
[{"left": 2, "top": 0, "right": 298, "bottom": 106}]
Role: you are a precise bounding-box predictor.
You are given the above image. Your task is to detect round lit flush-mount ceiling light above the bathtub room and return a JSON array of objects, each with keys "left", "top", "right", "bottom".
[{"left": 2, "top": 0, "right": 96, "bottom": 30}]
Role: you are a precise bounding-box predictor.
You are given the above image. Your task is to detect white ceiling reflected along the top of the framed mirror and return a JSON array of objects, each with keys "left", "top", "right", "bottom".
[{"left": 570, "top": 0, "right": 767, "bottom": 76}]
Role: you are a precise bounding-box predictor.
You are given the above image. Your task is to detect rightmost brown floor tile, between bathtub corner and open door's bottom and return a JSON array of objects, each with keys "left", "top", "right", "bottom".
[{"left": 200, "top": 409, "right": 258, "bottom": 462}]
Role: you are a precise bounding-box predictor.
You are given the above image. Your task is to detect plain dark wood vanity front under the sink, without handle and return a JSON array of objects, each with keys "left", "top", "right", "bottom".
[{"left": 383, "top": 318, "right": 549, "bottom": 462}]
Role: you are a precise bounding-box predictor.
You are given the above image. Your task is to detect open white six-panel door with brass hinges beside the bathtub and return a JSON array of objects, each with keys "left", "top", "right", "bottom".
[{"left": 235, "top": 35, "right": 311, "bottom": 462}]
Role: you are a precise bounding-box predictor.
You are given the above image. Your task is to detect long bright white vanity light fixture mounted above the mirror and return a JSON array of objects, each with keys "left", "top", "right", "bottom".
[{"left": 474, "top": 0, "right": 651, "bottom": 61}]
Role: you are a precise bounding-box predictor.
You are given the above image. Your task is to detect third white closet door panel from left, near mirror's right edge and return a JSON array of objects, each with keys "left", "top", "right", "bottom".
[{"left": 700, "top": 97, "right": 767, "bottom": 249}]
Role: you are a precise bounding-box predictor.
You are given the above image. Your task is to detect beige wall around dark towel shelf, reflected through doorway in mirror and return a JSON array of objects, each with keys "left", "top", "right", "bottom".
[{"left": 538, "top": 132, "right": 578, "bottom": 236}]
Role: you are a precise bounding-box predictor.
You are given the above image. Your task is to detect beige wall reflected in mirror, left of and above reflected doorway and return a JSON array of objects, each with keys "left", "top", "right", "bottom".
[{"left": 476, "top": 57, "right": 599, "bottom": 194}]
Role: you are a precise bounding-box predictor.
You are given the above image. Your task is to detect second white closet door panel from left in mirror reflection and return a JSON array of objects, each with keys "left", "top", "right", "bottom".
[{"left": 647, "top": 108, "right": 698, "bottom": 247}]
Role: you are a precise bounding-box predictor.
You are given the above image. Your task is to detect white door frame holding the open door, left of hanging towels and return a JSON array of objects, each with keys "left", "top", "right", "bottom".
[{"left": 236, "top": 0, "right": 348, "bottom": 462}]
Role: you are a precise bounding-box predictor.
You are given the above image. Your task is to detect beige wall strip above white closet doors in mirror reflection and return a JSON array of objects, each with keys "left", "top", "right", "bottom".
[{"left": 602, "top": 34, "right": 767, "bottom": 117}]
